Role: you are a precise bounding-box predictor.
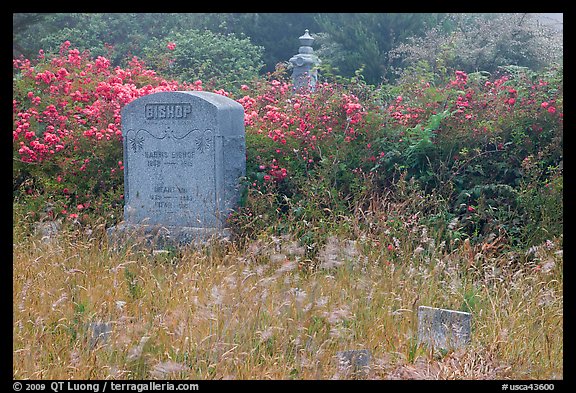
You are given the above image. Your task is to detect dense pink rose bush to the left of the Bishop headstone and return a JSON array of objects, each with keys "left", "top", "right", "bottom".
[{"left": 12, "top": 41, "right": 202, "bottom": 222}]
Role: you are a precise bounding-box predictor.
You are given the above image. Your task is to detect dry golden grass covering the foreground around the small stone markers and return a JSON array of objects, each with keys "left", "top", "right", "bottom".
[{"left": 13, "top": 222, "right": 563, "bottom": 379}]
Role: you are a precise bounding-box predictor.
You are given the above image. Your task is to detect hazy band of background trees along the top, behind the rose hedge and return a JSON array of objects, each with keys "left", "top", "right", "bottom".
[{"left": 13, "top": 13, "right": 561, "bottom": 84}]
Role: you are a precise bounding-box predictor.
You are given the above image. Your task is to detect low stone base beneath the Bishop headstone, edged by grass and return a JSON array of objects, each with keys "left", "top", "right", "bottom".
[{"left": 106, "top": 222, "right": 231, "bottom": 249}]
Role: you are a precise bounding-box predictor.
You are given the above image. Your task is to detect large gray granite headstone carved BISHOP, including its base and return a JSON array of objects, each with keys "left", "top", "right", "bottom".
[{"left": 108, "top": 91, "right": 246, "bottom": 244}]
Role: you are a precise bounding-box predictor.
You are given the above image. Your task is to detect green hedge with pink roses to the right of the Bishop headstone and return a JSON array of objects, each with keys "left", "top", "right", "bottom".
[{"left": 230, "top": 63, "right": 562, "bottom": 248}]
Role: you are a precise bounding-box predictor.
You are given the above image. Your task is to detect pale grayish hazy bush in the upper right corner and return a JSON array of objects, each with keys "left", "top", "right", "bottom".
[{"left": 389, "top": 13, "right": 563, "bottom": 79}]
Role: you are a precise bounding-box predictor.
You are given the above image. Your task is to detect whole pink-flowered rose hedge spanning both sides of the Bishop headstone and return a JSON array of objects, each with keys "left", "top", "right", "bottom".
[{"left": 13, "top": 41, "right": 563, "bottom": 245}]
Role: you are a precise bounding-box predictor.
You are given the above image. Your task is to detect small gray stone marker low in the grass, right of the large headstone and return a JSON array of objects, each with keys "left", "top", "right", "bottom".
[{"left": 418, "top": 306, "right": 472, "bottom": 350}]
